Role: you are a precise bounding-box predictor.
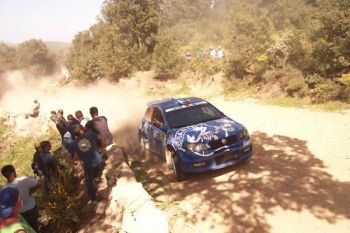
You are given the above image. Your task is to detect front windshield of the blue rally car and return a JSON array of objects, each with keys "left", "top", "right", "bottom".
[{"left": 167, "top": 104, "right": 224, "bottom": 128}]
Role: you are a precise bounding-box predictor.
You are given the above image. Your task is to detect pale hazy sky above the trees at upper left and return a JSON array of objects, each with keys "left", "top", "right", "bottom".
[{"left": 0, "top": 0, "right": 104, "bottom": 43}]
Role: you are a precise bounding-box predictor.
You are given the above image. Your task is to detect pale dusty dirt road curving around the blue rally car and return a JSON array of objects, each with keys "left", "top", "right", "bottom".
[{"left": 0, "top": 71, "right": 350, "bottom": 233}]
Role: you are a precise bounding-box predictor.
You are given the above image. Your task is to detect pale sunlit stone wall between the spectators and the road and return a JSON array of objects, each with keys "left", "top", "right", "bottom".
[{"left": 79, "top": 147, "right": 169, "bottom": 233}]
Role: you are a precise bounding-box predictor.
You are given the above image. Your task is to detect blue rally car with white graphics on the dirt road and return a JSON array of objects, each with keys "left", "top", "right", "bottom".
[{"left": 139, "top": 97, "right": 253, "bottom": 180}]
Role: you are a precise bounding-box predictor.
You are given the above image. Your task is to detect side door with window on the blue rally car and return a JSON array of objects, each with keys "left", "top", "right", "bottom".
[{"left": 150, "top": 108, "right": 166, "bottom": 156}]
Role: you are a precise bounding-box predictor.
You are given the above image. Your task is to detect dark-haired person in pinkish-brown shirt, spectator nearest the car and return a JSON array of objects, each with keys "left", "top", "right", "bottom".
[{"left": 85, "top": 107, "right": 113, "bottom": 146}]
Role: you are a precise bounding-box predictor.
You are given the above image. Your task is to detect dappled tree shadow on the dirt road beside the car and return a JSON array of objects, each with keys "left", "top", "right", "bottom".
[{"left": 111, "top": 125, "right": 350, "bottom": 233}]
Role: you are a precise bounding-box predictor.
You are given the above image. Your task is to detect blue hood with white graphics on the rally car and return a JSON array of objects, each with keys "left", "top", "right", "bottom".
[{"left": 170, "top": 118, "right": 243, "bottom": 150}]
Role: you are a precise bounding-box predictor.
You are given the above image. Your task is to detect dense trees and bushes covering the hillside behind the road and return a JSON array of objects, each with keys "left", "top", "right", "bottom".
[{"left": 66, "top": 0, "right": 350, "bottom": 102}]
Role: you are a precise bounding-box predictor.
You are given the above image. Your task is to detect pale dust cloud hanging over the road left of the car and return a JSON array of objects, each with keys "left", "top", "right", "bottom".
[{"left": 0, "top": 71, "right": 159, "bottom": 138}]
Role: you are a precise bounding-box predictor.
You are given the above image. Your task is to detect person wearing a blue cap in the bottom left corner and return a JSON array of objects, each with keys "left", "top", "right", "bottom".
[{"left": 0, "top": 187, "right": 35, "bottom": 233}]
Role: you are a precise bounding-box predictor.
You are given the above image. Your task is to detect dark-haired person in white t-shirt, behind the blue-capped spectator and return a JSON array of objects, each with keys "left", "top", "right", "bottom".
[{"left": 1, "top": 165, "right": 42, "bottom": 232}]
